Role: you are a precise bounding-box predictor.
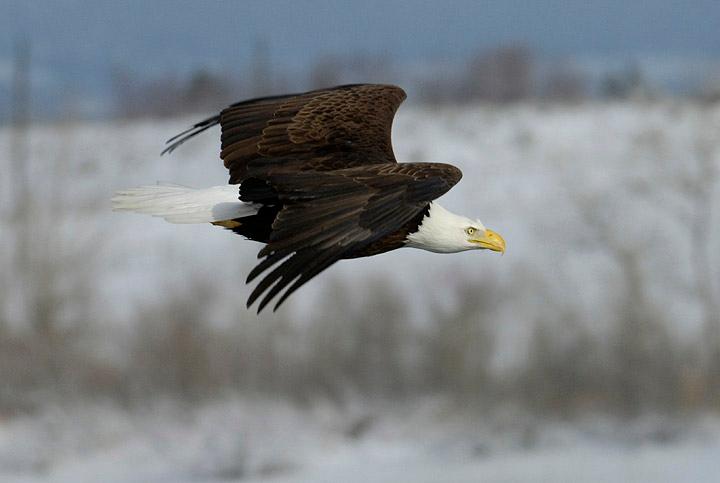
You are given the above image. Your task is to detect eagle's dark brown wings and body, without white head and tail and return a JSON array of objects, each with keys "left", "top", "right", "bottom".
[{"left": 164, "top": 84, "right": 462, "bottom": 311}]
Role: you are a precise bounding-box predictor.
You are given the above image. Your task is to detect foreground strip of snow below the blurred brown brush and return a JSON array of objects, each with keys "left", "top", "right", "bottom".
[{"left": 0, "top": 398, "right": 720, "bottom": 483}]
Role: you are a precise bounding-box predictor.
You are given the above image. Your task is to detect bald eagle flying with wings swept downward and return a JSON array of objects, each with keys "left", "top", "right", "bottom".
[{"left": 112, "top": 84, "right": 505, "bottom": 312}]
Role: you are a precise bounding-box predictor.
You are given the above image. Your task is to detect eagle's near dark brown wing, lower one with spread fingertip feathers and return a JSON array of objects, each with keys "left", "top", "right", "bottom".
[{"left": 242, "top": 163, "right": 462, "bottom": 312}]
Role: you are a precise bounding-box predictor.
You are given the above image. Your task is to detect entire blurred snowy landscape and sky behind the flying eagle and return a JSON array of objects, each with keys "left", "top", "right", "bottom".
[{"left": 0, "top": 0, "right": 720, "bottom": 482}]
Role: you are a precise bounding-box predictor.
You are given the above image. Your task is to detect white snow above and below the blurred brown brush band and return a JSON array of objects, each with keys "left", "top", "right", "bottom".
[{"left": 0, "top": 101, "right": 720, "bottom": 483}]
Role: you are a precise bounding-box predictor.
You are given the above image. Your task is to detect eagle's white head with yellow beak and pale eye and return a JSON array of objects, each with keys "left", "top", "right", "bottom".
[{"left": 405, "top": 202, "right": 505, "bottom": 253}]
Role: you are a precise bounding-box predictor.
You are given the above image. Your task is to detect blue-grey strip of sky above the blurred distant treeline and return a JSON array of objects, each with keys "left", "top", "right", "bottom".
[{"left": 0, "top": 0, "right": 720, "bottom": 117}]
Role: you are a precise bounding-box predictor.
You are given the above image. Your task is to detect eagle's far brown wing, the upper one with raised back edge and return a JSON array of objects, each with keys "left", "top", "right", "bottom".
[{"left": 163, "top": 84, "right": 406, "bottom": 184}]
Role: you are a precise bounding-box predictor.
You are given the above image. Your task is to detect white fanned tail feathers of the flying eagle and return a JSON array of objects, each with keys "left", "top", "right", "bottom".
[{"left": 112, "top": 184, "right": 257, "bottom": 223}]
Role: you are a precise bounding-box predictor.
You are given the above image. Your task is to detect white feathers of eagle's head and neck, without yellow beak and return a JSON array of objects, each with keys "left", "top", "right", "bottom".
[{"left": 405, "top": 202, "right": 470, "bottom": 253}]
